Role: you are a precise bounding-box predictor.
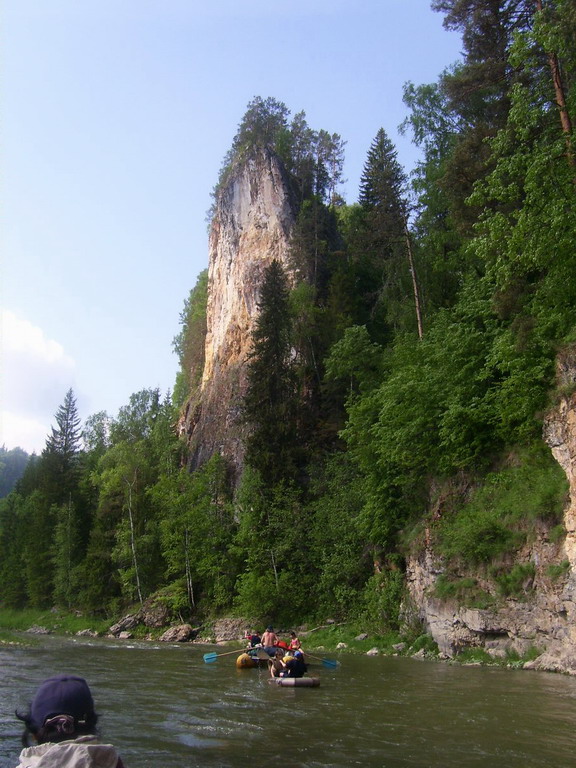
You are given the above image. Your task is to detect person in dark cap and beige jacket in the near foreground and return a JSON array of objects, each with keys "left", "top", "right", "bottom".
[{"left": 16, "top": 675, "right": 124, "bottom": 768}]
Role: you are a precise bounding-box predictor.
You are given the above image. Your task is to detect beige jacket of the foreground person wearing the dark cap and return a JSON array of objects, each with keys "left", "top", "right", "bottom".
[{"left": 17, "top": 736, "right": 122, "bottom": 768}]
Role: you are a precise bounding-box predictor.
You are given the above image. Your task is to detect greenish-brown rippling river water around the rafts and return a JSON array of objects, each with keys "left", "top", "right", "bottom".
[{"left": 0, "top": 637, "right": 576, "bottom": 768}]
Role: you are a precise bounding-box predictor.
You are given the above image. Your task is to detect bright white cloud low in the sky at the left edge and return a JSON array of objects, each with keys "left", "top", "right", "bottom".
[{"left": 0, "top": 310, "right": 75, "bottom": 453}]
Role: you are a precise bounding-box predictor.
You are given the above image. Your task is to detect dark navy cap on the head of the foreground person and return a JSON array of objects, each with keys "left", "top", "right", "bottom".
[{"left": 30, "top": 675, "right": 94, "bottom": 729}]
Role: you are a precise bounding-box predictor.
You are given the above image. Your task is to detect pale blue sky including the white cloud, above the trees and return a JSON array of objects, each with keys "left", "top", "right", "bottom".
[{"left": 0, "top": 0, "right": 461, "bottom": 452}]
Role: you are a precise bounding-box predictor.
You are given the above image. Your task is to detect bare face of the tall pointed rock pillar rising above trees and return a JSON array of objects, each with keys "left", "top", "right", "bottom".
[{"left": 183, "top": 150, "right": 295, "bottom": 475}]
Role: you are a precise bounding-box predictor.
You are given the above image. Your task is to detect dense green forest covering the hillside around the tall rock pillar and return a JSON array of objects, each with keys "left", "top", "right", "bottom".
[{"left": 0, "top": 0, "right": 576, "bottom": 630}]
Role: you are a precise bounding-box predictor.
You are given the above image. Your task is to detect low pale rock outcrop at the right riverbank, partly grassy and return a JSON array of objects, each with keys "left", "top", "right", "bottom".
[{"left": 408, "top": 355, "right": 576, "bottom": 674}]
